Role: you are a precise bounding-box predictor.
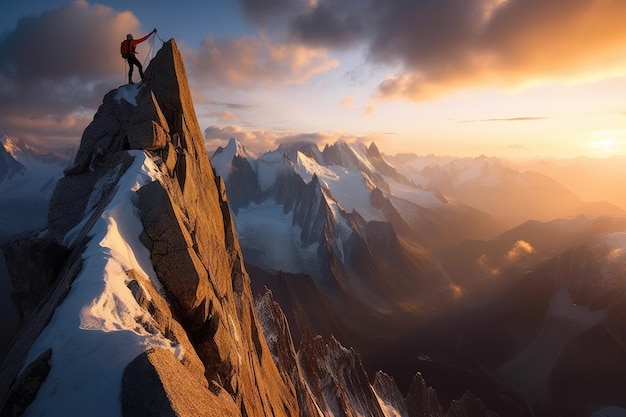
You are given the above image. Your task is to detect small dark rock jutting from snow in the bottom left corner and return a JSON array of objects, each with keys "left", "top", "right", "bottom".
[{"left": 2, "top": 349, "right": 52, "bottom": 417}]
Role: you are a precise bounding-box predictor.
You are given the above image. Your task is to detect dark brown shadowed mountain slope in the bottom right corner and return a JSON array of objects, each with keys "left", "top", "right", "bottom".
[{"left": 364, "top": 239, "right": 626, "bottom": 417}]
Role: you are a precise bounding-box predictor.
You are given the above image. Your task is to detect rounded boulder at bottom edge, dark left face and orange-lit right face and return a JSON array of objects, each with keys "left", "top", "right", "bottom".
[{"left": 122, "top": 349, "right": 241, "bottom": 417}]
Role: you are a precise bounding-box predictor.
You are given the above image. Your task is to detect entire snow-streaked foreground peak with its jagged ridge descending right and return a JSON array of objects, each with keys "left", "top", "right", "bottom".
[{"left": 0, "top": 40, "right": 490, "bottom": 417}]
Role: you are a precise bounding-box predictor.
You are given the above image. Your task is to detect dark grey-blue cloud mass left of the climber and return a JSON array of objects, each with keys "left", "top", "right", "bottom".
[{"left": 0, "top": 1, "right": 140, "bottom": 150}]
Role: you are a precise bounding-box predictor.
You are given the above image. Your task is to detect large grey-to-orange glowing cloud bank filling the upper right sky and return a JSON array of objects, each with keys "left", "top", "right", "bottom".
[{"left": 240, "top": 0, "right": 626, "bottom": 100}]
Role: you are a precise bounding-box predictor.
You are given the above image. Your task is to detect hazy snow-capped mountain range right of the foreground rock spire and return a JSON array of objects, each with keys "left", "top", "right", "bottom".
[{"left": 212, "top": 139, "right": 626, "bottom": 417}]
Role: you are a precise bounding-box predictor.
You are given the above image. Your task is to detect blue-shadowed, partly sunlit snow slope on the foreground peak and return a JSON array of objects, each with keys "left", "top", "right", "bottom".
[{"left": 25, "top": 151, "right": 174, "bottom": 416}]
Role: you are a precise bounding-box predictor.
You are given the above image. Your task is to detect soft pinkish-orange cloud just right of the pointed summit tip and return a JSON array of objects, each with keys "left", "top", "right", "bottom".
[{"left": 185, "top": 36, "right": 339, "bottom": 87}]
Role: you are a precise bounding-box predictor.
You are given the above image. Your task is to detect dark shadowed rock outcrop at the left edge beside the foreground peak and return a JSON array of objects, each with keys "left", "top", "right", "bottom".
[{"left": 0, "top": 232, "right": 69, "bottom": 320}]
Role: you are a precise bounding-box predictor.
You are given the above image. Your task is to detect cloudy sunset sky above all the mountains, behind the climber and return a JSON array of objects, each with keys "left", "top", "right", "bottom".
[{"left": 0, "top": 0, "right": 626, "bottom": 158}]
